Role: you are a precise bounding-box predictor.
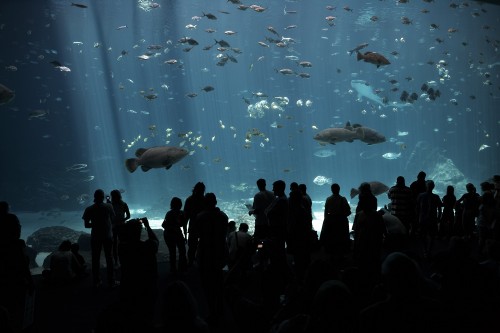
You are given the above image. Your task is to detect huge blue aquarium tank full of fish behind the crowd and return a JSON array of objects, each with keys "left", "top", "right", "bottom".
[{"left": 0, "top": 0, "right": 500, "bottom": 238}]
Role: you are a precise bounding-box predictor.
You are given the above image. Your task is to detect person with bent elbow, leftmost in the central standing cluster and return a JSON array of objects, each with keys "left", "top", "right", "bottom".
[{"left": 248, "top": 178, "right": 274, "bottom": 242}]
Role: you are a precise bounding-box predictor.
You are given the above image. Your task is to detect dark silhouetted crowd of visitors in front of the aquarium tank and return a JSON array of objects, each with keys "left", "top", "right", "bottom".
[{"left": 0, "top": 171, "right": 500, "bottom": 333}]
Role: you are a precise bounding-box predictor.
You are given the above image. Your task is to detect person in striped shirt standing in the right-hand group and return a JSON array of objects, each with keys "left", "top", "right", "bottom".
[{"left": 387, "top": 176, "right": 415, "bottom": 232}]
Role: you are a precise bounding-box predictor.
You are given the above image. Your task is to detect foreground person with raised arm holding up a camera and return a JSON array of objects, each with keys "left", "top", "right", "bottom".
[{"left": 118, "top": 217, "right": 159, "bottom": 320}]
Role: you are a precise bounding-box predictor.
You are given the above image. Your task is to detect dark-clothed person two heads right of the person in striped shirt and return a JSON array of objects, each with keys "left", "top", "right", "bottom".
[{"left": 417, "top": 180, "right": 443, "bottom": 257}]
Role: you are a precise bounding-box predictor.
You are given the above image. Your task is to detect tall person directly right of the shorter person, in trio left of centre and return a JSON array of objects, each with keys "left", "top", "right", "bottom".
[{"left": 184, "top": 182, "right": 205, "bottom": 266}]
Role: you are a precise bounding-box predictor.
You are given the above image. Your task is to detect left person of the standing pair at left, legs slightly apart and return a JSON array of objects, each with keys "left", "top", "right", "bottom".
[{"left": 82, "top": 189, "right": 116, "bottom": 288}]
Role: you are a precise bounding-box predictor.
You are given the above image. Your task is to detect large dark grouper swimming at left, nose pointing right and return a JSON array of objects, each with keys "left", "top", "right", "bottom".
[{"left": 125, "top": 146, "right": 189, "bottom": 172}]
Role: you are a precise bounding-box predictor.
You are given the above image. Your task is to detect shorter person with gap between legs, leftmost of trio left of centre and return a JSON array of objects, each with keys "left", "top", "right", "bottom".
[{"left": 161, "top": 197, "right": 187, "bottom": 273}]
